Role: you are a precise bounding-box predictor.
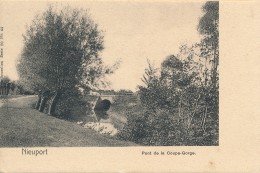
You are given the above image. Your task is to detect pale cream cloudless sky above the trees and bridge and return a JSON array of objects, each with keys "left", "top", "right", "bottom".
[{"left": 0, "top": 1, "right": 205, "bottom": 91}]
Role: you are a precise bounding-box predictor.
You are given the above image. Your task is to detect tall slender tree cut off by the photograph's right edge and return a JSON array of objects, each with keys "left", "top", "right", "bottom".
[{"left": 198, "top": 1, "right": 219, "bottom": 121}]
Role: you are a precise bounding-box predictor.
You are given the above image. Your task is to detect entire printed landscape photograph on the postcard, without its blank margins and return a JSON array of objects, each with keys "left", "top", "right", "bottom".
[{"left": 0, "top": 1, "right": 219, "bottom": 148}]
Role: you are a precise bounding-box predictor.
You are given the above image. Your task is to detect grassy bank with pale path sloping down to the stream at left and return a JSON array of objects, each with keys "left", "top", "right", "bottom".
[{"left": 0, "top": 97, "right": 136, "bottom": 147}]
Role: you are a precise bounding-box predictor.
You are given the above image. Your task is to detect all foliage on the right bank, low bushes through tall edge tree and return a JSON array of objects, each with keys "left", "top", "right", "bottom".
[{"left": 119, "top": 2, "right": 219, "bottom": 145}]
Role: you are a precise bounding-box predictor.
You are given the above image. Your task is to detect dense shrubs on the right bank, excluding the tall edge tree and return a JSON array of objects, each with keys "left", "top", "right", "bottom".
[{"left": 119, "top": 53, "right": 219, "bottom": 146}]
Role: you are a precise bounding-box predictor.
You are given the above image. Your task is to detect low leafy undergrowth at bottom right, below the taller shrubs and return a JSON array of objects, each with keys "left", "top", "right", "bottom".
[{"left": 118, "top": 109, "right": 218, "bottom": 146}]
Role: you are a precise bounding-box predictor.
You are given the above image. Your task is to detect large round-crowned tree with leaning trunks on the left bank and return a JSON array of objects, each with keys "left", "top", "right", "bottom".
[{"left": 17, "top": 6, "right": 116, "bottom": 114}]
